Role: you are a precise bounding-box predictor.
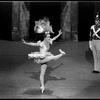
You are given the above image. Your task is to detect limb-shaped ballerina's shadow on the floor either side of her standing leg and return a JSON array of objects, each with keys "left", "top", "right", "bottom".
[{"left": 24, "top": 63, "right": 66, "bottom": 84}]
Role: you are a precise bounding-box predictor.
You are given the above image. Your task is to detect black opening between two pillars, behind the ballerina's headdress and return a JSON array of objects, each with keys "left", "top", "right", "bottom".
[{"left": 29, "top": 2, "right": 61, "bottom": 40}]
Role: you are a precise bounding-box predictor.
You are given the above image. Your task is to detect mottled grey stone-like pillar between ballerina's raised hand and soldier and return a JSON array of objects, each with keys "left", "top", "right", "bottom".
[{"left": 61, "top": 1, "right": 78, "bottom": 42}]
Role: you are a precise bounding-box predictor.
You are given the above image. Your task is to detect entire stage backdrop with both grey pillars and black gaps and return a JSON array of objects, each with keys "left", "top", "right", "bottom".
[{"left": 0, "top": 1, "right": 100, "bottom": 41}]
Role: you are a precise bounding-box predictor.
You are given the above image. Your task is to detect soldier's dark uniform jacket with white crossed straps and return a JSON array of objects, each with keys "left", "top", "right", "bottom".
[{"left": 89, "top": 25, "right": 100, "bottom": 41}]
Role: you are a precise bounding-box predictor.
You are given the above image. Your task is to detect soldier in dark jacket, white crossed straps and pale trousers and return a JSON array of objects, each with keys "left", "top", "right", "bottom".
[{"left": 89, "top": 13, "right": 100, "bottom": 73}]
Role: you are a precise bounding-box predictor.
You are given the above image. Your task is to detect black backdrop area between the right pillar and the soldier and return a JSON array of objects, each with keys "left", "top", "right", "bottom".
[{"left": 78, "top": 2, "right": 95, "bottom": 41}]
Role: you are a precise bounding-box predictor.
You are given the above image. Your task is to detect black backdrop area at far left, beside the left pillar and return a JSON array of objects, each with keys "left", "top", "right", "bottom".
[{"left": 0, "top": 2, "right": 12, "bottom": 40}]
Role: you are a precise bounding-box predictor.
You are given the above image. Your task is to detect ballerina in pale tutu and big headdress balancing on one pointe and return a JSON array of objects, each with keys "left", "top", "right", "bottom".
[{"left": 22, "top": 18, "right": 65, "bottom": 93}]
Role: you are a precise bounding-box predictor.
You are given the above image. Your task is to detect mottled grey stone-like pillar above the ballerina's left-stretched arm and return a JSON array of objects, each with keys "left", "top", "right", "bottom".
[{"left": 12, "top": 1, "right": 30, "bottom": 40}]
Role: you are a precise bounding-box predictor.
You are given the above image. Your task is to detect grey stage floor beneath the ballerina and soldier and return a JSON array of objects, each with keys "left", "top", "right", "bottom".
[{"left": 0, "top": 40, "right": 100, "bottom": 99}]
